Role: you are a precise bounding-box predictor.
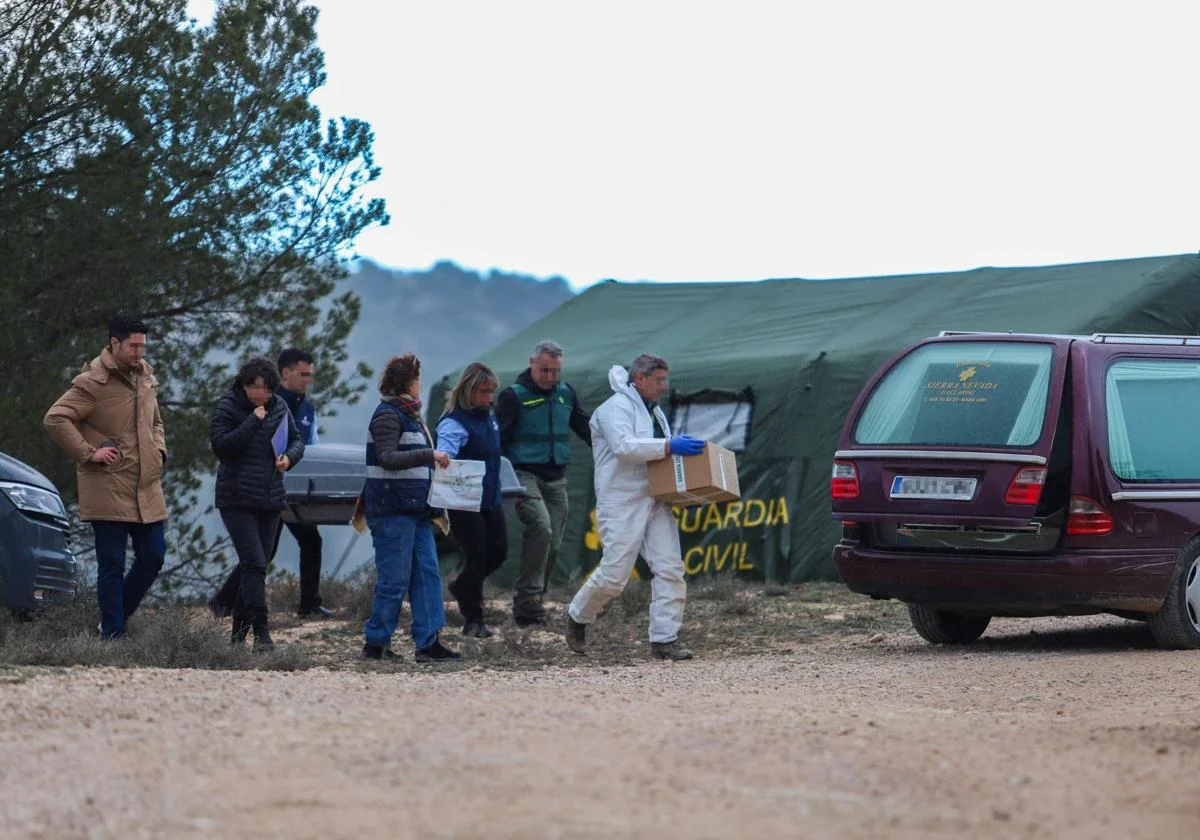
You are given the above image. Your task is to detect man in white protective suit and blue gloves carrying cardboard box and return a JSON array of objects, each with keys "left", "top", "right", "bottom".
[{"left": 566, "top": 354, "right": 704, "bottom": 661}]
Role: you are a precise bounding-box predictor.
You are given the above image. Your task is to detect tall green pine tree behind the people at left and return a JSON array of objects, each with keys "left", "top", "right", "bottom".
[{"left": 0, "top": 0, "right": 388, "bottom": 586}]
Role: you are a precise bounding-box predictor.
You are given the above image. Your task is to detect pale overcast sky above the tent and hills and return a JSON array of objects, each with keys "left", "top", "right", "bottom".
[{"left": 191, "top": 0, "right": 1200, "bottom": 288}]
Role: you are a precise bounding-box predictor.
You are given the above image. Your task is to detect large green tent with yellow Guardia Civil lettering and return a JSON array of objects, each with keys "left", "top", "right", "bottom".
[{"left": 430, "top": 254, "right": 1200, "bottom": 583}]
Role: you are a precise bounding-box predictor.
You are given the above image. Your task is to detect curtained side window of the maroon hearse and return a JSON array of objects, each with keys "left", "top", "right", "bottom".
[{"left": 1104, "top": 359, "right": 1200, "bottom": 481}]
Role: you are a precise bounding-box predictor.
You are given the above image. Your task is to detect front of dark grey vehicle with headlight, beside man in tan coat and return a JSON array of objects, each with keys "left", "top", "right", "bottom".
[{"left": 0, "top": 454, "right": 77, "bottom": 612}]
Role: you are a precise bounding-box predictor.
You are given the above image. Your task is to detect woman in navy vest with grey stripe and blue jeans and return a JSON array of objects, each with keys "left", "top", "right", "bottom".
[{"left": 362, "top": 354, "right": 461, "bottom": 662}]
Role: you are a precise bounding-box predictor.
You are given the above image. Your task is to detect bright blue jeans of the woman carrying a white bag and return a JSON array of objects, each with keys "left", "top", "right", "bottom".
[{"left": 362, "top": 514, "right": 446, "bottom": 650}]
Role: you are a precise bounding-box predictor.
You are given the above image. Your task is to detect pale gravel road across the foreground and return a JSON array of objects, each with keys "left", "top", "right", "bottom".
[{"left": 0, "top": 609, "right": 1200, "bottom": 839}]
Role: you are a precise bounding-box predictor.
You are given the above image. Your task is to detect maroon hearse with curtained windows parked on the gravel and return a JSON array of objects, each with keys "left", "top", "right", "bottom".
[{"left": 832, "top": 332, "right": 1200, "bottom": 648}]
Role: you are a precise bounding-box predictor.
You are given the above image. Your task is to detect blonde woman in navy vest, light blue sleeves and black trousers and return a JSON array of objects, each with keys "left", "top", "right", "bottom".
[{"left": 438, "top": 361, "right": 509, "bottom": 638}]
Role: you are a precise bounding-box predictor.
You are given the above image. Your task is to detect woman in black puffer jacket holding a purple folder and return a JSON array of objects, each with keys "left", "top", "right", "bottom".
[{"left": 209, "top": 356, "right": 304, "bottom": 650}]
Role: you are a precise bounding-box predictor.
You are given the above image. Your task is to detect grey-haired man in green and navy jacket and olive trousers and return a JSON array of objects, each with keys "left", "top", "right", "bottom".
[{"left": 496, "top": 341, "right": 592, "bottom": 626}]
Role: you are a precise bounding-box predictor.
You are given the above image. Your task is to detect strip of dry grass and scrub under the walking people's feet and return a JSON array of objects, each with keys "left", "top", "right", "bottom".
[{"left": 0, "top": 570, "right": 908, "bottom": 680}]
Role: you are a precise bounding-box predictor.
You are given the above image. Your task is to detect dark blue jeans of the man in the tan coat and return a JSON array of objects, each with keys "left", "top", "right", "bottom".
[{"left": 91, "top": 522, "right": 167, "bottom": 638}]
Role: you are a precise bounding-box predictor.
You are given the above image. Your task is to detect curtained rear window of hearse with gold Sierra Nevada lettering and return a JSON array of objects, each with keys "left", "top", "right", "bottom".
[{"left": 854, "top": 341, "right": 1054, "bottom": 446}]
